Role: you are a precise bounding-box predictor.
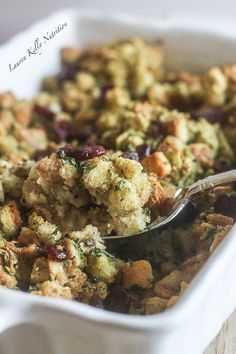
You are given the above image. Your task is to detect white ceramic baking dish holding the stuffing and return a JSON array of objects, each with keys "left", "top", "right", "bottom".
[{"left": 0, "top": 9, "right": 236, "bottom": 354}]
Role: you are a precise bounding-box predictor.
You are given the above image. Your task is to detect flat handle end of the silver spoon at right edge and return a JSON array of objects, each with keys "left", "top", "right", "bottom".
[{"left": 188, "top": 170, "right": 236, "bottom": 196}]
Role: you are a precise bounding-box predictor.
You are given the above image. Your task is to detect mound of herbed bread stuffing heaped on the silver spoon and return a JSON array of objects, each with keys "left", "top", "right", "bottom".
[{"left": 23, "top": 149, "right": 151, "bottom": 232}]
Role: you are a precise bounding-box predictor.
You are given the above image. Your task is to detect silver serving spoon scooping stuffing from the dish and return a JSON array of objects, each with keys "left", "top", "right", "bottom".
[{"left": 103, "top": 170, "right": 236, "bottom": 240}]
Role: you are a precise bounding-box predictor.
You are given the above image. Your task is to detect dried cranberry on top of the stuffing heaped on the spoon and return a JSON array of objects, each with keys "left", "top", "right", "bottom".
[{"left": 57, "top": 144, "right": 106, "bottom": 161}]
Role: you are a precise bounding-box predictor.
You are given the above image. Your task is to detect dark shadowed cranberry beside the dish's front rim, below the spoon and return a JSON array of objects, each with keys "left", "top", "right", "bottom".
[{"left": 105, "top": 286, "right": 129, "bottom": 313}]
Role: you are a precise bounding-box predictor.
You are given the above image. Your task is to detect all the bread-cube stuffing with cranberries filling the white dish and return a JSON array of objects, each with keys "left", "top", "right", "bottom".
[{"left": 0, "top": 37, "right": 236, "bottom": 315}]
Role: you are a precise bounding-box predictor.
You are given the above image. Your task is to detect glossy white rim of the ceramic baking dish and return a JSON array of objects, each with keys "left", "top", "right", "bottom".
[{"left": 0, "top": 7, "right": 236, "bottom": 331}]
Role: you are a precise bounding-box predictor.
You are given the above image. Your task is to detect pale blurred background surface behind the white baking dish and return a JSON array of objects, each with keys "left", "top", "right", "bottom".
[{"left": 0, "top": 0, "right": 236, "bottom": 43}]
